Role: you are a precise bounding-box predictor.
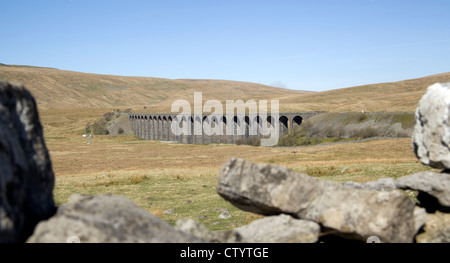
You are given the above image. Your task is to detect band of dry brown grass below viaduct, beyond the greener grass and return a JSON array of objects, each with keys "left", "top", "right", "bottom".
[{"left": 40, "top": 106, "right": 432, "bottom": 184}]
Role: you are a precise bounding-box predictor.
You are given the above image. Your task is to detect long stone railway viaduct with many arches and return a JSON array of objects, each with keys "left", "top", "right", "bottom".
[{"left": 129, "top": 111, "right": 323, "bottom": 144}]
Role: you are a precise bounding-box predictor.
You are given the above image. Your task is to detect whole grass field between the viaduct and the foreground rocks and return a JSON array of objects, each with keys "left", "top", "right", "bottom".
[{"left": 40, "top": 109, "right": 438, "bottom": 230}]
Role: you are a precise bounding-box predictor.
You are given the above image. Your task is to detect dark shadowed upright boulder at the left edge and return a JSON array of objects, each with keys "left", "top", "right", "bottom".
[{"left": 0, "top": 81, "right": 56, "bottom": 242}]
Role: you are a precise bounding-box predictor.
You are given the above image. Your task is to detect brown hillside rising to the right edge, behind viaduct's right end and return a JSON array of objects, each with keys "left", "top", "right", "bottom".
[{"left": 279, "top": 72, "right": 450, "bottom": 112}]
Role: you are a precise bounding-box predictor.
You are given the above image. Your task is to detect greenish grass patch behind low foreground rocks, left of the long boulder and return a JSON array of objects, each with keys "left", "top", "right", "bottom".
[{"left": 54, "top": 172, "right": 257, "bottom": 230}]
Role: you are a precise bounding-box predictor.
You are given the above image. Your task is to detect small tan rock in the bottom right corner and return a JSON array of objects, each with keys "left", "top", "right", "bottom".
[{"left": 416, "top": 212, "right": 450, "bottom": 243}]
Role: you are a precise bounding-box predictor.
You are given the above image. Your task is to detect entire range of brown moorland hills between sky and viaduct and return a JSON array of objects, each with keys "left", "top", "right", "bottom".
[{"left": 0, "top": 64, "right": 450, "bottom": 112}]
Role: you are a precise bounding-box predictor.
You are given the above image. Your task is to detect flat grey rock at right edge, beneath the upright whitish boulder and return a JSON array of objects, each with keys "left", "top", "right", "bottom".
[{"left": 395, "top": 172, "right": 450, "bottom": 212}]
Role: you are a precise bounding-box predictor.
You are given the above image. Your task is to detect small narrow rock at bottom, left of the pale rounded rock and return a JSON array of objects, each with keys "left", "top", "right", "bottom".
[{"left": 175, "top": 219, "right": 242, "bottom": 243}]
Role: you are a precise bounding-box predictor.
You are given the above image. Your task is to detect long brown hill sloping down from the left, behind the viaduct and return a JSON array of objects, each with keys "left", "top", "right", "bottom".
[{"left": 0, "top": 64, "right": 310, "bottom": 112}]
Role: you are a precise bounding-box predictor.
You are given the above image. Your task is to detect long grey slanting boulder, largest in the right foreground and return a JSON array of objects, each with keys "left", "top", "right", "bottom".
[{"left": 217, "top": 158, "right": 415, "bottom": 242}]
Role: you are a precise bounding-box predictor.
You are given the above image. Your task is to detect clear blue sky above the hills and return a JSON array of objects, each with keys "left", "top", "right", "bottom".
[{"left": 0, "top": 0, "right": 450, "bottom": 91}]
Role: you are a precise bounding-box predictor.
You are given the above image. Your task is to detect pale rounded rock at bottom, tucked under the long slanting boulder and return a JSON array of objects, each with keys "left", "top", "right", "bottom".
[{"left": 234, "top": 214, "right": 320, "bottom": 243}]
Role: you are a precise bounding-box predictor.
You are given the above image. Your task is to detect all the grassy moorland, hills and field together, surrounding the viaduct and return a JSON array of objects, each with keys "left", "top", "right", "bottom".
[{"left": 0, "top": 65, "right": 442, "bottom": 230}]
